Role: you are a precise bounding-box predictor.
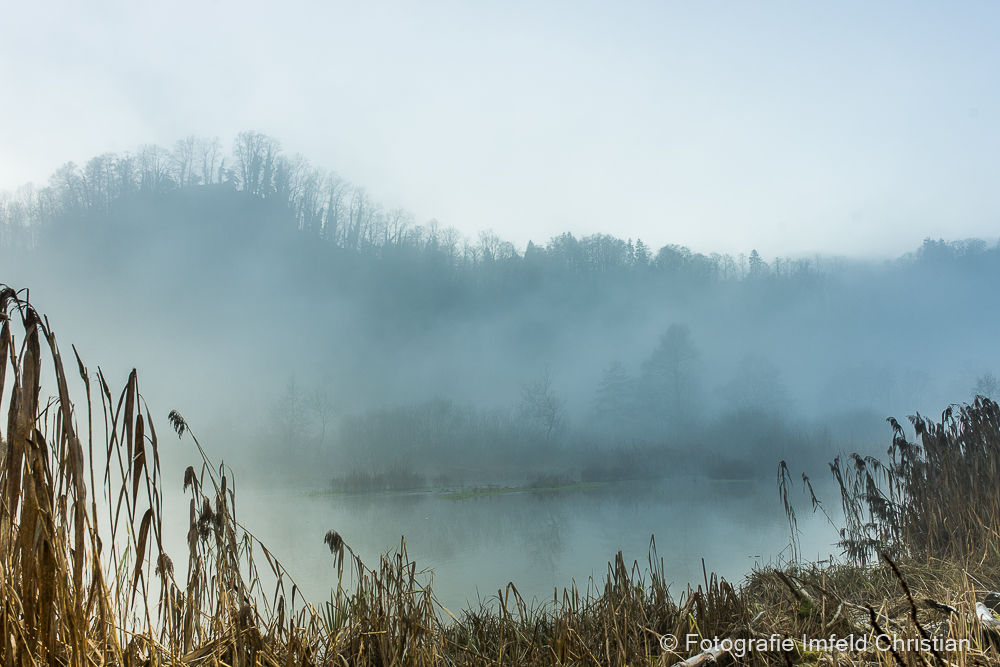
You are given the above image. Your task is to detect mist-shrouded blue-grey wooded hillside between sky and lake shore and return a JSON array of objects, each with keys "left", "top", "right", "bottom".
[{"left": 0, "top": 132, "right": 1000, "bottom": 480}]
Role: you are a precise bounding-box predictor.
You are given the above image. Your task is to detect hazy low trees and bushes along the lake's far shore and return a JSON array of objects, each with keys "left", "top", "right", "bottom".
[{"left": 288, "top": 324, "right": 829, "bottom": 483}]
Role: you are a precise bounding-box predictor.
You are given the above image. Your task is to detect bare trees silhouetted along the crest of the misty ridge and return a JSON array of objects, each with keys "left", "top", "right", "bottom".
[{"left": 0, "top": 131, "right": 896, "bottom": 282}]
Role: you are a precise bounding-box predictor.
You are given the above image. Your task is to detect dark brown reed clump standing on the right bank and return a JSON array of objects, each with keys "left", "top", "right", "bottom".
[{"left": 830, "top": 396, "right": 1000, "bottom": 564}]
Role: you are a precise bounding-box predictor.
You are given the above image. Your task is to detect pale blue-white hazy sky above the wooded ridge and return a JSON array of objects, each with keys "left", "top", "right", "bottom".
[{"left": 0, "top": 0, "right": 1000, "bottom": 258}]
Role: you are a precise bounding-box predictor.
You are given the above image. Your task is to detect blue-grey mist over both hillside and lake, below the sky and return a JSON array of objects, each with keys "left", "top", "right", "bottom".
[{"left": 0, "top": 138, "right": 1000, "bottom": 606}]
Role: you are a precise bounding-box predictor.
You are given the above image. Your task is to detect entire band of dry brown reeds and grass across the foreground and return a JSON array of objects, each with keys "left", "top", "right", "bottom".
[{"left": 0, "top": 285, "right": 1000, "bottom": 667}]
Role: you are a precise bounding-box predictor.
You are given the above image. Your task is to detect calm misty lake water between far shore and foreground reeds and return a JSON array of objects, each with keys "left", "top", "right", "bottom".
[{"left": 165, "top": 478, "right": 840, "bottom": 615}]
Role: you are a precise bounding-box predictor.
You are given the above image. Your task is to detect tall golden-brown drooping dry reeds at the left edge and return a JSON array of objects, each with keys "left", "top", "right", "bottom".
[{"left": 0, "top": 286, "right": 320, "bottom": 667}]
